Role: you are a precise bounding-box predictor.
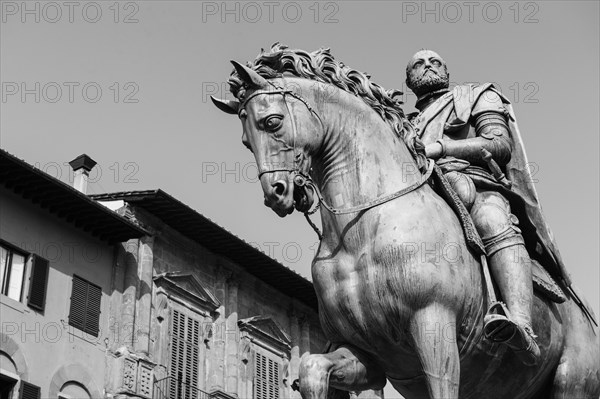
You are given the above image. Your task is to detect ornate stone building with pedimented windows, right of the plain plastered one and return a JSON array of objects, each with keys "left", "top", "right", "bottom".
[{"left": 93, "top": 190, "right": 326, "bottom": 399}]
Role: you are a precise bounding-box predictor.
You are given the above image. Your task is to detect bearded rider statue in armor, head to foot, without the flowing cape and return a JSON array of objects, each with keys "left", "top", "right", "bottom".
[{"left": 406, "top": 50, "right": 540, "bottom": 365}]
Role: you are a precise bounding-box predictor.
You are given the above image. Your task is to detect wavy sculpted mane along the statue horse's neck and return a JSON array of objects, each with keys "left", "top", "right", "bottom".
[{"left": 229, "top": 43, "right": 427, "bottom": 172}]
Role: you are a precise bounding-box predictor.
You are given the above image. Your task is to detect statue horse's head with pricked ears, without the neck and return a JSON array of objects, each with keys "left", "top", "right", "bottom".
[{"left": 212, "top": 61, "right": 323, "bottom": 217}]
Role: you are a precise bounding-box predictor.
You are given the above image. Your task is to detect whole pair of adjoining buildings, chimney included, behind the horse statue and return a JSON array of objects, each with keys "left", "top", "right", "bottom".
[{"left": 0, "top": 150, "right": 370, "bottom": 399}]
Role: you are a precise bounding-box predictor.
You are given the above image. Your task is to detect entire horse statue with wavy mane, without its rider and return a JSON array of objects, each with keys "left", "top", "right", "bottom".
[{"left": 213, "top": 44, "right": 600, "bottom": 399}]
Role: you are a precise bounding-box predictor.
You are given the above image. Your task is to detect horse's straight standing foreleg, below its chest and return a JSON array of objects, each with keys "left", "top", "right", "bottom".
[{"left": 411, "top": 305, "right": 460, "bottom": 399}]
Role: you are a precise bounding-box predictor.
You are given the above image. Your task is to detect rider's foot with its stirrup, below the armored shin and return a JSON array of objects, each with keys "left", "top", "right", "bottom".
[{"left": 483, "top": 302, "right": 540, "bottom": 366}]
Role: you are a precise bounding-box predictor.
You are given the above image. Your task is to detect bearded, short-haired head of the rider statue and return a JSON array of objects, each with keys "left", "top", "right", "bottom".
[{"left": 406, "top": 50, "right": 450, "bottom": 99}]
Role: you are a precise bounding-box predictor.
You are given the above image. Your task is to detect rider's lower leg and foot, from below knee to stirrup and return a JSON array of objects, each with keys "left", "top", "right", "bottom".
[{"left": 484, "top": 244, "right": 540, "bottom": 366}]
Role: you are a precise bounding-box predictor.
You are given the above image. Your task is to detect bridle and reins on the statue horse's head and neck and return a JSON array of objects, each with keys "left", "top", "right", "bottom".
[{"left": 238, "top": 81, "right": 435, "bottom": 240}]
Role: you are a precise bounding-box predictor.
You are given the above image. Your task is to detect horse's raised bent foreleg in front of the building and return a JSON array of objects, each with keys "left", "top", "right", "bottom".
[{"left": 299, "top": 346, "right": 386, "bottom": 399}]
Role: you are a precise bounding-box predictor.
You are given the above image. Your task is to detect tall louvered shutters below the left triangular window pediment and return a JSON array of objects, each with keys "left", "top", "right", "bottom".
[{"left": 169, "top": 310, "right": 200, "bottom": 399}]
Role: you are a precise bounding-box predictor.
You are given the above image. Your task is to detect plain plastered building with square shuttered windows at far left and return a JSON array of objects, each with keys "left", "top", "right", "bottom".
[{"left": 0, "top": 150, "right": 147, "bottom": 399}]
